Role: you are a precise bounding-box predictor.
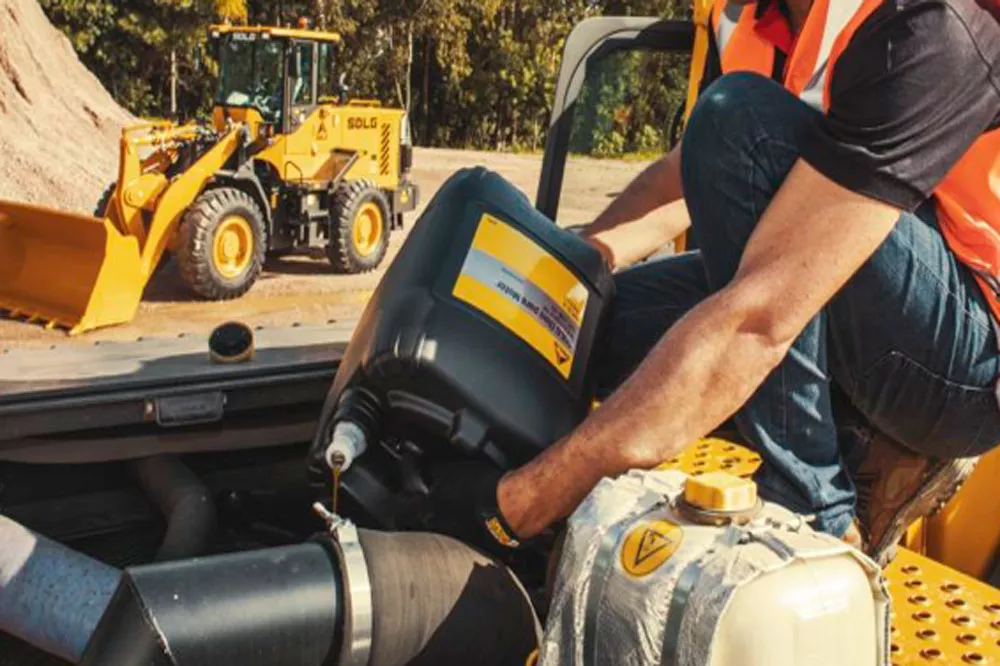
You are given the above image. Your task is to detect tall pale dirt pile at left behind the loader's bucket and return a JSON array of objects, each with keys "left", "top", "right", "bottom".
[{"left": 0, "top": 0, "right": 132, "bottom": 213}]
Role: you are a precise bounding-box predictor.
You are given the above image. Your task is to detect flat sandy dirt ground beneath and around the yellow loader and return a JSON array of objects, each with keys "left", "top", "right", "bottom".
[{"left": 0, "top": 149, "right": 644, "bottom": 350}]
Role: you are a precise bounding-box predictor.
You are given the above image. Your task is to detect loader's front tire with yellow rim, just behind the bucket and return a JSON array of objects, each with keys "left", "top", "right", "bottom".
[{"left": 177, "top": 187, "right": 267, "bottom": 301}]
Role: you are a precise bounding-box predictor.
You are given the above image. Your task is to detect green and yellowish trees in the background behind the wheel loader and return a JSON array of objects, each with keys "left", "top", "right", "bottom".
[{"left": 41, "top": 0, "right": 689, "bottom": 156}]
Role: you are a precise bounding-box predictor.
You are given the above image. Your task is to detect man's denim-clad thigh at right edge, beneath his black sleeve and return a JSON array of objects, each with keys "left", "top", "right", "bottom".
[{"left": 827, "top": 204, "right": 1000, "bottom": 457}]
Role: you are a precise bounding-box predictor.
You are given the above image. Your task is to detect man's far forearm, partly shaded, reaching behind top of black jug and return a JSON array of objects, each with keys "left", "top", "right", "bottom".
[{"left": 583, "top": 145, "right": 691, "bottom": 268}]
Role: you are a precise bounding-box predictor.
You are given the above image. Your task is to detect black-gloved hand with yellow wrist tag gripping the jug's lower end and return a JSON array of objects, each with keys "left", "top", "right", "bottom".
[{"left": 430, "top": 461, "right": 521, "bottom": 556}]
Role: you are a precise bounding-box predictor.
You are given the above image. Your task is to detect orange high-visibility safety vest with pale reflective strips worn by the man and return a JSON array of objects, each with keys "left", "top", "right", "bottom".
[{"left": 712, "top": 0, "right": 1000, "bottom": 321}]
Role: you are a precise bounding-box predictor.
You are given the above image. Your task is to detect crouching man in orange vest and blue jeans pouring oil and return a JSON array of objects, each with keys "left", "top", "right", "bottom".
[{"left": 443, "top": 0, "right": 1000, "bottom": 560}]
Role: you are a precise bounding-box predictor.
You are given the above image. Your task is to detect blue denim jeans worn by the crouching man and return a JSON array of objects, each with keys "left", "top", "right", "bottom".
[{"left": 600, "top": 74, "right": 1000, "bottom": 536}]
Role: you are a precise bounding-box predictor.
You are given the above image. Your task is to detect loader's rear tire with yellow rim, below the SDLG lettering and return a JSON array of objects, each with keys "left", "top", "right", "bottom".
[{"left": 326, "top": 180, "right": 392, "bottom": 274}]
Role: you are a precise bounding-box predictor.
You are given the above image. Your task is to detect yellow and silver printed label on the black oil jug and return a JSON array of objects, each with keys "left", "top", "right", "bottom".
[{"left": 452, "top": 214, "right": 590, "bottom": 379}]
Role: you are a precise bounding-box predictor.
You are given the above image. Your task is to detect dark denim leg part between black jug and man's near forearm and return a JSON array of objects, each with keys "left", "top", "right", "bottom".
[{"left": 598, "top": 252, "right": 709, "bottom": 398}]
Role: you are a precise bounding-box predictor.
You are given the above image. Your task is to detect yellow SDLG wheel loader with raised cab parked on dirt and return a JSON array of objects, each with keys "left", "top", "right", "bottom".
[{"left": 0, "top": 26, "right": 419, "bottom": 334}]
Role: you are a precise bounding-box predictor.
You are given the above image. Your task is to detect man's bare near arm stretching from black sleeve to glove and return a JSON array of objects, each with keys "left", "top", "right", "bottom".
[{"left": 497, "top": 160, "right": 900, "bottom": 537}]
